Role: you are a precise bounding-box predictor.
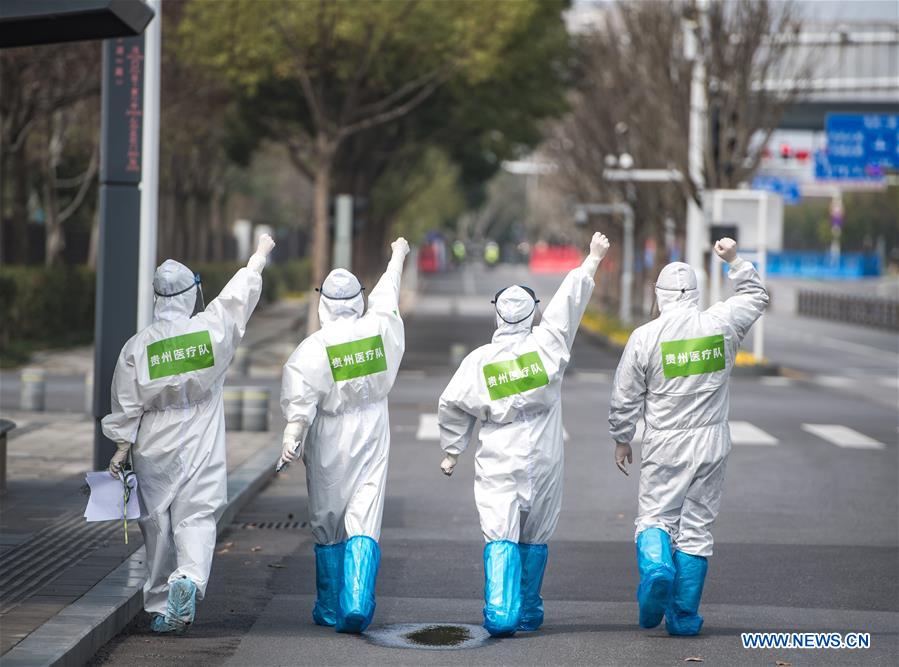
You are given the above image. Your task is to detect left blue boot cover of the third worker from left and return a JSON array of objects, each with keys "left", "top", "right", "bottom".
[{"left": 484, "top": 540, "right": 521, "bottom": 637}]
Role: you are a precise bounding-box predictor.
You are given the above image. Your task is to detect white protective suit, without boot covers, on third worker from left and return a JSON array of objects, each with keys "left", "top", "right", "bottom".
[{"left": 437, "top": 259, "right": 599, "bottom": 544}]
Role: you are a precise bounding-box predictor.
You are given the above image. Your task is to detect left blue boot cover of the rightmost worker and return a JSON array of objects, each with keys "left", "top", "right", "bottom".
[{"left": 637, "top": 528, "right": 675, "bottom": 628}]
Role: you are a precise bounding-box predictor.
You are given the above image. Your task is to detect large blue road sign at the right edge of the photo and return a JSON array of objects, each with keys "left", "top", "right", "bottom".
[{"left": 815, "top": 113, "right": 899, "bottom": 180}]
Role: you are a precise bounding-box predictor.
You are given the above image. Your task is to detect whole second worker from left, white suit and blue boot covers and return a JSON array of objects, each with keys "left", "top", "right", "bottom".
[{"left": 281, "top": 238, "right": 409, "bottom": 633}]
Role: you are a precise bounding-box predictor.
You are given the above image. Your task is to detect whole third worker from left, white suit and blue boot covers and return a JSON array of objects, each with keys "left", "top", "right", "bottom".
[{"left": 437, "top": 233, "right": 609, "bottom": 636}]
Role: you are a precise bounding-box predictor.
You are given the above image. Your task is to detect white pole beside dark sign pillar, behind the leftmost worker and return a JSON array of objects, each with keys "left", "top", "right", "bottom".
[{"left": 137, "top": 0, "right": 162, "bottom": 331}]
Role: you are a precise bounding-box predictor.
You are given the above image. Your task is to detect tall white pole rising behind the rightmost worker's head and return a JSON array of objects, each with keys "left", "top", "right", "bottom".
[{"left": 684, "top": 0, "right": 708, "bottom": 307}]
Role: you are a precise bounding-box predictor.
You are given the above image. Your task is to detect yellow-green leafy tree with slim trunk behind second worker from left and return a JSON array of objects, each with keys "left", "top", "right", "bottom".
[{"left": 183, "top": 0, "right": 568, "bottom": 328}]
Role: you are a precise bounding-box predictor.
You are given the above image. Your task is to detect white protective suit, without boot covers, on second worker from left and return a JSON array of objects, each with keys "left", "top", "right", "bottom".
[{"left": 281, "top": 253, "right": 406, "bottom": 545}]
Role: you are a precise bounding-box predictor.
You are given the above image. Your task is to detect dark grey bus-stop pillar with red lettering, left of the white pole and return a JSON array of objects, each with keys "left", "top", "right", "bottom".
[{"left": 94, "top": 35, "right": 144, "bottom": 469}]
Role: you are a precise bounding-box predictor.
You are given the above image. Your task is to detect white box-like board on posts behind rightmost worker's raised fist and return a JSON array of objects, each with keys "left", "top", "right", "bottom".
[{"left": 704, "top": 190, "right": 783, "bottom": 251}]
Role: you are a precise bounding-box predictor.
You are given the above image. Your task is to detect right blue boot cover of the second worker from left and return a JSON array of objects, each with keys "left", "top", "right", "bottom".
[{"left": 337, "top": 535, "right": 381, "bottom": 634}]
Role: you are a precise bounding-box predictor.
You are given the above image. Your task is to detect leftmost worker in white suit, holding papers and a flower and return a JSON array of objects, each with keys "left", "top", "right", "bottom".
[{"left": 103, "top": 234, "right": 275, "bottom": 632}]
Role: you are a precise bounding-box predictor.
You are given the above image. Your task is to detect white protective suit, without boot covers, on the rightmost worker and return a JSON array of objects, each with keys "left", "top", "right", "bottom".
[{"left": 609, "top": 257, "right": 768, "bottom": 557}]
